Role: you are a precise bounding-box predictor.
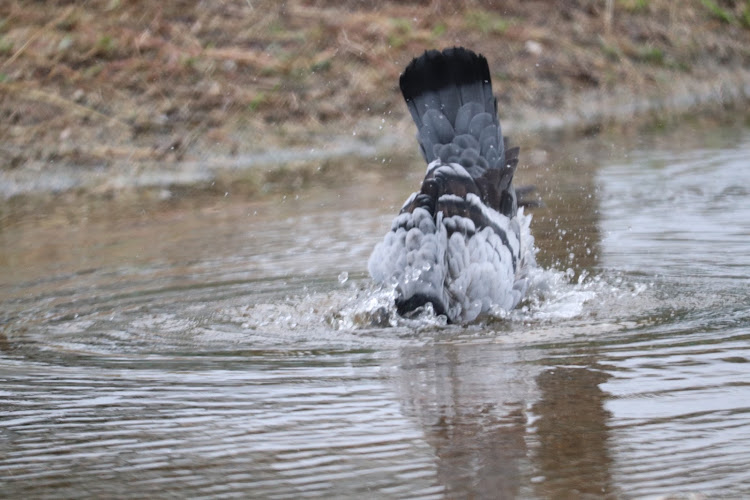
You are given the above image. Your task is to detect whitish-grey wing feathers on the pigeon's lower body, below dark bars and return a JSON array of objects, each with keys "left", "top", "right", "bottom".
[{"left": 368, "top": 186, "right": 535, "bottom": 322}]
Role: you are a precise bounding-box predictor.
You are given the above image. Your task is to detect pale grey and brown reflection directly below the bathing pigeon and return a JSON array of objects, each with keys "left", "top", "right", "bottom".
[{"left": 398, "top": 342, "right": 539, "bottom": 498}]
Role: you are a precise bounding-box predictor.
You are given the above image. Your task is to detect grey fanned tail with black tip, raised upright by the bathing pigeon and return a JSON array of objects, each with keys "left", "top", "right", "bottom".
[{"left": 399, "top": 47, "right": 518, "bottom": 216}]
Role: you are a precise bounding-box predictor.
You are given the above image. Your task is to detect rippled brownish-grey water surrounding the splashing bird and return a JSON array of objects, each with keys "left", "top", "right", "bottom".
[{"left": 0, "top": 122, "right": 750, "bottom": 498}]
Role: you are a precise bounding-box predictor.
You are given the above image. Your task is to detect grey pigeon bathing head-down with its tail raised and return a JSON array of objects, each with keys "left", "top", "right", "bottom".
[{"left": 368, "top": 47, "right": 535, "bottom": 323}]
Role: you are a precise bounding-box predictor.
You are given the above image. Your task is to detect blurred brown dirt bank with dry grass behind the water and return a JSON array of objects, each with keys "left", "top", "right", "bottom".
[{"left": 0, "top": 0, "right": 750, "bottom": 198}]
